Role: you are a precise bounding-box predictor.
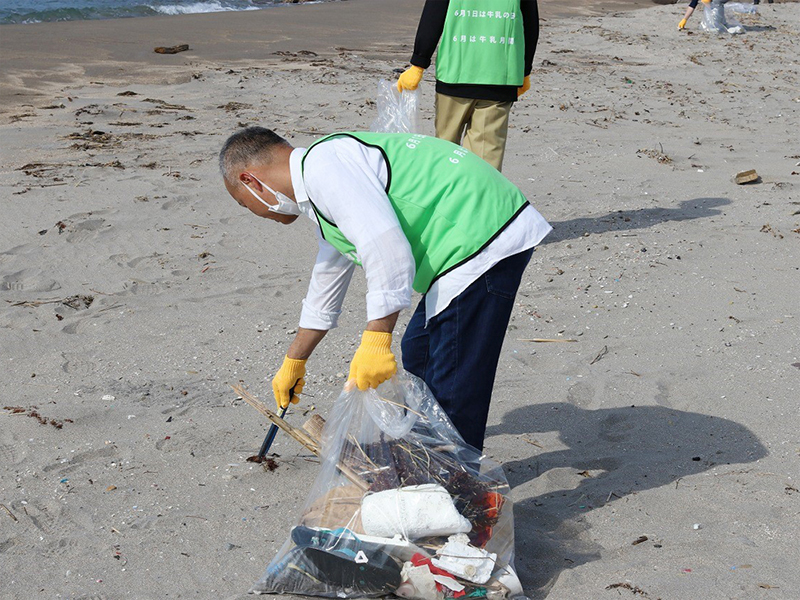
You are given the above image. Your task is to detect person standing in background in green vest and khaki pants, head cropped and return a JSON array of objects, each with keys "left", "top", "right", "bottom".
[{"left": 397, "top": 0, "right": 539, "bottom": 171}]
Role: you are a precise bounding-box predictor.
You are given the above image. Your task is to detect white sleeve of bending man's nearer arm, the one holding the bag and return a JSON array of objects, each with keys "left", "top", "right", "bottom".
[{"left": 305, "top": 138, "right": 415, "bottom": 321}]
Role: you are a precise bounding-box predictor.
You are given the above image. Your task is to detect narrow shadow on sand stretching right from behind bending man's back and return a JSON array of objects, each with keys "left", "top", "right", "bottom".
[{"left": 540, "top": 198, "right": 731, "bottom": 245}]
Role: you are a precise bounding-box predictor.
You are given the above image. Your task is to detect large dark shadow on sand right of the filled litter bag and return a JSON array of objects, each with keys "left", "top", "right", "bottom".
[{"left": 486, "top": 403, "right": 767, "bottom": 598}]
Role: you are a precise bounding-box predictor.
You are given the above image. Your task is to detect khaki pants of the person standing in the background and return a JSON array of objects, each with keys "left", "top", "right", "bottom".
[{"left": 436, "top": 93, "right": 513, "bottom": 171}]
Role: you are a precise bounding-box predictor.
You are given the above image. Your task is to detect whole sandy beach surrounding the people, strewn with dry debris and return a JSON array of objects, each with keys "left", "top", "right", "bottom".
[{"left": 0, "top": 0, "right": 800, "bottom": 600}]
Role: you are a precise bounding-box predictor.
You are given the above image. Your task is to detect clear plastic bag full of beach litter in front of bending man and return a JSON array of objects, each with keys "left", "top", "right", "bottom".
[{"left": 251, "top": 372, "right": 524, "bottom": 600}]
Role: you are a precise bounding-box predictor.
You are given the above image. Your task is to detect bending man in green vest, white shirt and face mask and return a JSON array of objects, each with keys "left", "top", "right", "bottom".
[{"left": 220, "top": 127, "right": 551, "bottom": 449}]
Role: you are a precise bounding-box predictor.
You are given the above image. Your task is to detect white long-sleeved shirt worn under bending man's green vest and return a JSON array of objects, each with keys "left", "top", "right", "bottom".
[{"left": 289, "top": 137, "right": 552, "bottom": 330}]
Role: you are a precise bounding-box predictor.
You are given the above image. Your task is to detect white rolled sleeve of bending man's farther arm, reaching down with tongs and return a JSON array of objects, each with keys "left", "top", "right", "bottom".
[{"left": 299, "top": 229, "right": 355, "bottom": 331}]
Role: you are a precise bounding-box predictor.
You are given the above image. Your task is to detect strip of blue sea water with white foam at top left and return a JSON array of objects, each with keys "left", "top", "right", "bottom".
[{"left": 0, "top": 0, "right": 298, "bottom": 24}]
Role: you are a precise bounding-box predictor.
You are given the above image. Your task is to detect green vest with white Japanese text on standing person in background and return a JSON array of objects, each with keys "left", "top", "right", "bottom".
[{"left": 436, "top": 0, "right": 525, "bottom": 87}]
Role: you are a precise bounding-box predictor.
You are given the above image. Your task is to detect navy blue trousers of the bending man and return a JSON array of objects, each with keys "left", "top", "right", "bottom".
[{"left": 401, "top": 249, "right": 533, "bottom": 450}]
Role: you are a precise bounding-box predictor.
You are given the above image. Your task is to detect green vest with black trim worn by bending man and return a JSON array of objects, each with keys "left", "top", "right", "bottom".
[{"left": 301, "top": 133, "right": 528, "bottom": 294}]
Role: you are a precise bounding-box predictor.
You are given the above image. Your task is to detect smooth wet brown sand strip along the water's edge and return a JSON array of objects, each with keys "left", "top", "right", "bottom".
[{"left": 0, "top": 0, "right": 688, "bottom": 114}]
